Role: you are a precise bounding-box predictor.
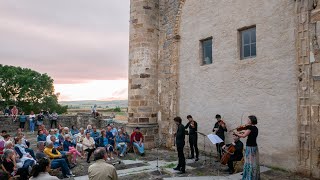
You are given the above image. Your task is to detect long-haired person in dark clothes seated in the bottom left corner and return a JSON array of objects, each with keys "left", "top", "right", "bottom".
[{"left": 1, "top": 149, "right": 28, "bottom": 179}]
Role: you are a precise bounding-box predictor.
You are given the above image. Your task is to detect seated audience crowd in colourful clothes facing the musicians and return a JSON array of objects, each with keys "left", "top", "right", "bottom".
[{"left": 0, "top": 117, "right": 150, "bottom": 179}]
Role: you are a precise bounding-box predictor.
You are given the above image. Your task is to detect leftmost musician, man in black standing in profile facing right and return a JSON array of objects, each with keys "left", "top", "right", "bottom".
[{"left": 173, "top": 117, "right": 186, "bottom": 174}]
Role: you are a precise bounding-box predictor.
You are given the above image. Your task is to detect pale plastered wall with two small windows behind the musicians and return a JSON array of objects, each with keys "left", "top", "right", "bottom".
[{"left": 179, "top": 0, "right": 298, "bottom": 170}]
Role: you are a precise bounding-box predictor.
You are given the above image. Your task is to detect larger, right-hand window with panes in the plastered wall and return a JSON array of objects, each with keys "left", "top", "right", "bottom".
[{"left": 240, "top": 27, "right": 257, "bottom": 59}]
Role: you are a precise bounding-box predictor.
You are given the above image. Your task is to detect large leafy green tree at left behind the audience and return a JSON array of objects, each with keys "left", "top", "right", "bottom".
[{"left": 0, "top": 64, "right": 67, "bottom": 114}]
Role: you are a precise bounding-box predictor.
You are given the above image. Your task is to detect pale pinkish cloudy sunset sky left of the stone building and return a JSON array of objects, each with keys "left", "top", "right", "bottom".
[{"left": 0, "top": 0, "right": 130, "bottom": 101}]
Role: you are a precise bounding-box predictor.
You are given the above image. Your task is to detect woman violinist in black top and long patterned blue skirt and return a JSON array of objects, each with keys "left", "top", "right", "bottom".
[{"left": 235, "top": 115, "right": 260, "bottom": 180}]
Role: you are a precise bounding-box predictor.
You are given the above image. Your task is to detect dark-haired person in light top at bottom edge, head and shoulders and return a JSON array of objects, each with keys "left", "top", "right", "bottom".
[{"left": 30, "top": 158, "right": 59, "bottom": 180}]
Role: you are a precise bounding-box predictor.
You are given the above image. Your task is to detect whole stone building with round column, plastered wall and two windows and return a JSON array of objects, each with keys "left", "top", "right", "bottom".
[{"left": 127, "top": 0, "right": 320, "bottom": 178}]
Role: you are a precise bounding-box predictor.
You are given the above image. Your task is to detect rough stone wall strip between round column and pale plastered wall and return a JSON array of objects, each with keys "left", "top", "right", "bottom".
[{"left": 158, "top": 0, "right": 184, "bottom": 147}]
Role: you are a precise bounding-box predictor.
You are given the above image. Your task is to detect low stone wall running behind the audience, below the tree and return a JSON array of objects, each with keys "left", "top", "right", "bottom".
[{"left": 0, "top": 114, "right": 117, "bottom": 132}]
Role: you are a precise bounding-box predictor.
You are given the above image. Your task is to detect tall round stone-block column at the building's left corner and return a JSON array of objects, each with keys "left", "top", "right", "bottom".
[{"left": 127, "top": 0, "right": 159, "bottom": 148}]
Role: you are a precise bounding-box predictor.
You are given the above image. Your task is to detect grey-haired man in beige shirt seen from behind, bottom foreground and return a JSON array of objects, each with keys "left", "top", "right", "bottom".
[{"left": 88, "top": 147, "right": 118, "bottom": 180}]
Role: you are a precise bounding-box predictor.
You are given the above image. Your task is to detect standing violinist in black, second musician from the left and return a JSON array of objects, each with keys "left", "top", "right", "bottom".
[{"left": 184, "top": 115, "right": 199, "bottom": 161}]
